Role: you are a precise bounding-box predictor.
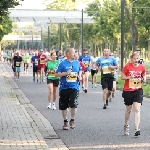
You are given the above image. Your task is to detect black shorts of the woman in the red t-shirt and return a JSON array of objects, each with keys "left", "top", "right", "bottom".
[{"left": 122, "top": 89, "right": 143, "bottom": 106}]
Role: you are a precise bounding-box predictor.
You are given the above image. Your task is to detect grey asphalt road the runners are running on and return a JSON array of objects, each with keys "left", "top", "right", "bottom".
[{"left": 4, "top": 64, "right": 150, "bottom": 150}]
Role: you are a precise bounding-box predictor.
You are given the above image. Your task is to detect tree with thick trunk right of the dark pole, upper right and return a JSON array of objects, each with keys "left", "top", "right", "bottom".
[{"left": 125, "top": 0, "right": 150, "bottom": 51}]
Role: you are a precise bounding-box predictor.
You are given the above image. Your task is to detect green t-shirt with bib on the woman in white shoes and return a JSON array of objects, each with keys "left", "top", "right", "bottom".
[{"left": 47, "top": 60, "right": 59, "bottom": 80}]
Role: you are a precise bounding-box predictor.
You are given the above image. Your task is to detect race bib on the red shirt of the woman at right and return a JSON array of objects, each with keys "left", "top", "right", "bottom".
[{"left": 129, "top": 79, "right": 142, "bottom": 89}]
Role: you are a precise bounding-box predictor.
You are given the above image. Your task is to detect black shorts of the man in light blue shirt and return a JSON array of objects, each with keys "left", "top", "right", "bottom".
[{"left": 101, "top": 77, "right": 114, "bottom": 91}]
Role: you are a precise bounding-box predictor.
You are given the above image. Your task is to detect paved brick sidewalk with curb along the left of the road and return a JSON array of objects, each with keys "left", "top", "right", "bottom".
[{"left": 0, "top": 62, "right": 68, "bottom": 150}]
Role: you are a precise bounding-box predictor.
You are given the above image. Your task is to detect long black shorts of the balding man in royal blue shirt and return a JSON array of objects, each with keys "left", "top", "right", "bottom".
[{"left": 59, "top": 89, "right": 79, "bottom": 110}]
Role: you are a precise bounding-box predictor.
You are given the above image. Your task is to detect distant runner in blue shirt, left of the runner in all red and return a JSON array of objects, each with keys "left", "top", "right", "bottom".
[{"left": 31, "top": 52, "right": 38, "bottom": 82}]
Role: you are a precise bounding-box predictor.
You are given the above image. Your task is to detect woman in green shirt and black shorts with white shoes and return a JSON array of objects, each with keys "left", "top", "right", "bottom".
[{"left": 45, "top": 52, "right": 59, "bottom": 110}]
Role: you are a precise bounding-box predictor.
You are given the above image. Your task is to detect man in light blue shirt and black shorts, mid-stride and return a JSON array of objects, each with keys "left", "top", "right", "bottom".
[{"left": 96, "top": 49, "right": 118, "bottom": 109}]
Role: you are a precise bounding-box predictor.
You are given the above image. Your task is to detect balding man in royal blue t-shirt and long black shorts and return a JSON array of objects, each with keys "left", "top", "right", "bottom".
[{"left": 55, "top": 48, "right": 82, "bottom": 130}]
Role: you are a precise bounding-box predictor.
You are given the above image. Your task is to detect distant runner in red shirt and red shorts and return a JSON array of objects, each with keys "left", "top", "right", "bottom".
[{"left": 38, "top": 50, "right": 47, "bottom": 82}]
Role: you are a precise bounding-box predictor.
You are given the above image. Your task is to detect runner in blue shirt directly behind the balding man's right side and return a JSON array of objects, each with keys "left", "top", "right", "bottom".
[{"left": 79, "top": 49, "right": 91, "bottom": 93}]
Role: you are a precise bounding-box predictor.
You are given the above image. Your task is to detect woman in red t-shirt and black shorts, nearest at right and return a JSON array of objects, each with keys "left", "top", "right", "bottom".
[{"left": 121, "top": 53, "right": 146, "bottom": 136}]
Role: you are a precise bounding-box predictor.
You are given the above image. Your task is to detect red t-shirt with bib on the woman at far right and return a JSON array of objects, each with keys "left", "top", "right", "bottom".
[{"left": 122, "top": 63, "right": 145, "bottom": 91}]
